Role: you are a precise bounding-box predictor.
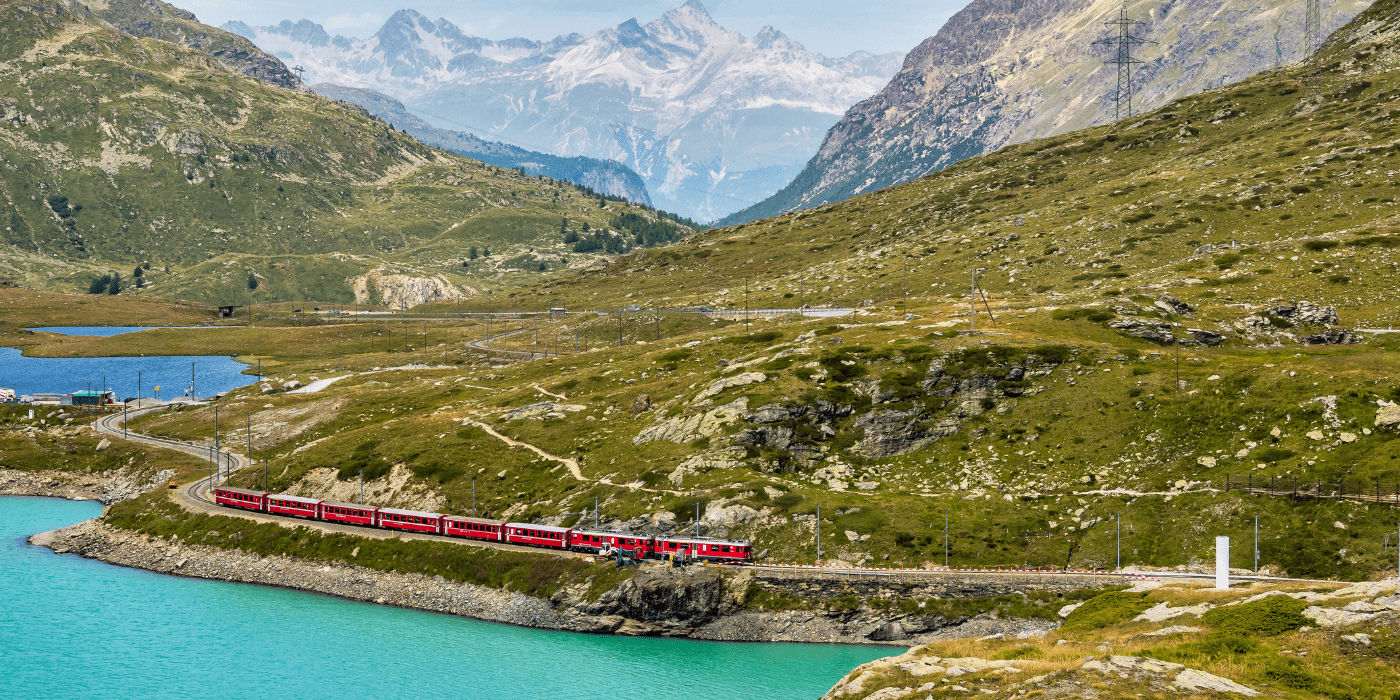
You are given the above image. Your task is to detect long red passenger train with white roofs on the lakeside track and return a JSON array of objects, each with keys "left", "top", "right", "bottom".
[{"left": 214, "top": 486, "right": 753, "bottom": 563}]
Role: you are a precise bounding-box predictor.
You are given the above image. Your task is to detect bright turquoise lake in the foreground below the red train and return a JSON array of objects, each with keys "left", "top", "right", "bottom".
[{"left": 0, "top": 497, "right": 892, "bottom": 700}]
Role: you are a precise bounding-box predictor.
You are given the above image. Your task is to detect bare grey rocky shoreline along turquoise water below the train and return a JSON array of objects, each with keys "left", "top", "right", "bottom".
[{"left": 29, "top": 519, "right": 1056, "bottom": 647}]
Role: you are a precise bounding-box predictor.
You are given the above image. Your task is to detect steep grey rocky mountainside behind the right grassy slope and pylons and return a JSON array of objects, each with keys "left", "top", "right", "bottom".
[{"left": 720, "top": 0, "right": 1369, "bottom": 225}]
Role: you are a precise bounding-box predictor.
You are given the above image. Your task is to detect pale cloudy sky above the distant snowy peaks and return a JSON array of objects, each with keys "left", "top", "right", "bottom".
[{"left": 172, "top": 0, "right": 969, "bottom": 56}]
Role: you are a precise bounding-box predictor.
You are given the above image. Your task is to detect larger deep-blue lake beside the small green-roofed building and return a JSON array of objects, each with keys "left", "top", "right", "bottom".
[{"left": 0, "top": 347, "right": 256, "bottom": 399}]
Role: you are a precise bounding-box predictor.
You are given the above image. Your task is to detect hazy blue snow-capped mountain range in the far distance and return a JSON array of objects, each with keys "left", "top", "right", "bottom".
[{"left": 223, "top": 0, "right": 903, "bottom": 220}]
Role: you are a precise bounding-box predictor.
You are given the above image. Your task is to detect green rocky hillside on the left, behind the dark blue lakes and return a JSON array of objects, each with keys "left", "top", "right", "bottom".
[{"left": 0, "top": 3, "right": 685, "bottom": 302}]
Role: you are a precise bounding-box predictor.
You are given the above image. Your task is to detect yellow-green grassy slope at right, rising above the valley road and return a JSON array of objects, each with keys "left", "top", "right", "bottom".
[{"left": 523, "top": 3, "right": 1400, "bottom": 323}]
